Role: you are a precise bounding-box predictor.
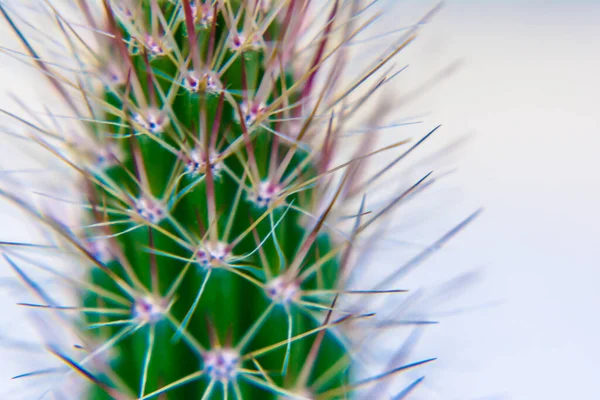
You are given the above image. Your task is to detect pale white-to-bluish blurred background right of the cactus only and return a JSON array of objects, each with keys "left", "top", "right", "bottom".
[{"left": 368, "top": 1, "right": 600, "bottom": 399}]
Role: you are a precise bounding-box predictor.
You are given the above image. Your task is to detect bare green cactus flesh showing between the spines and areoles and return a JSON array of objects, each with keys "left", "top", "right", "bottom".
[{"left": 83, "top": 1, "right": 349, "bottom": 399}]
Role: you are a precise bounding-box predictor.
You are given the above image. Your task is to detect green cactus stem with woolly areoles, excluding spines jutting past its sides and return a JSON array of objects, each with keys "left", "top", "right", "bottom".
[{"left": 84, "top": 1, "right": 349, "bottom": 399}]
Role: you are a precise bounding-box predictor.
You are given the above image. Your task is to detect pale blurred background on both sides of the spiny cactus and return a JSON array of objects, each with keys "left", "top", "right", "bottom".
[{"left": 0, "top": 0, "right": 600, "bottom": 399}]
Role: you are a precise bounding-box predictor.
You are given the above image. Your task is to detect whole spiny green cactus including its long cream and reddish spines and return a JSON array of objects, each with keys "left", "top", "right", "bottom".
[{"left": 0, "top": 0, "right": 473, "bottom": 399}]
